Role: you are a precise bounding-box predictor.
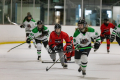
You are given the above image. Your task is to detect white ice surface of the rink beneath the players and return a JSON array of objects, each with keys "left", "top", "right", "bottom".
[{"left": 0, "top": 44, "right": 120, "bottom": 80}]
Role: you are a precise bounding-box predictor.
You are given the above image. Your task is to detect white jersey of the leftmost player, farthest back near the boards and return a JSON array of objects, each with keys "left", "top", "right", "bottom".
[{"left": 23, "top": 19, "right": 37, "bottom": 33}]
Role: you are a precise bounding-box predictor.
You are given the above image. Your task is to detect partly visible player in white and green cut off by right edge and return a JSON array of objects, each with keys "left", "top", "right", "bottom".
[{"left": 110, "top": 24, "right": 120, "bottom": 46}]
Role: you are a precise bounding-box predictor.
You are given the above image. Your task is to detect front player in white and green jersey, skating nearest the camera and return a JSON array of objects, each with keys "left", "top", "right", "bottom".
[{"left": 73, "top": 19, "right": 101, "bottom": 75}]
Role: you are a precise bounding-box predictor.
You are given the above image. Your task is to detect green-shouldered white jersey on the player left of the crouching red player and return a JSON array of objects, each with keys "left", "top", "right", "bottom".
[{"left": 29, "top": 26, "right": 49, "bottom": 41}]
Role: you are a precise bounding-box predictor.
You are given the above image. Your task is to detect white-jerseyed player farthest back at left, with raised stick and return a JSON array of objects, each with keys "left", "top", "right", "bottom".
[{"left": 20, "top": 15, "right": 37, "bottom": 48}]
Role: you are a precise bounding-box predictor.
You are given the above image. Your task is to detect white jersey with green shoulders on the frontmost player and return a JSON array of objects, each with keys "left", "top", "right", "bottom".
[{"left": 73, "top": 27, "right": 101, "bottom": 47}]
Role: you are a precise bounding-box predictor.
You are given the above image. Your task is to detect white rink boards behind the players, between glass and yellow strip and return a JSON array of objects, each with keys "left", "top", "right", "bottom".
[{"left": 0, "top": 25, "right": 114, "bottom": 42}]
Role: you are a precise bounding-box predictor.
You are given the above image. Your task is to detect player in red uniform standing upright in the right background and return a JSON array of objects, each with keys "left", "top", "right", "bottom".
[{"left": 100, "top": 19, "right": 115, "bottom": 53}]
